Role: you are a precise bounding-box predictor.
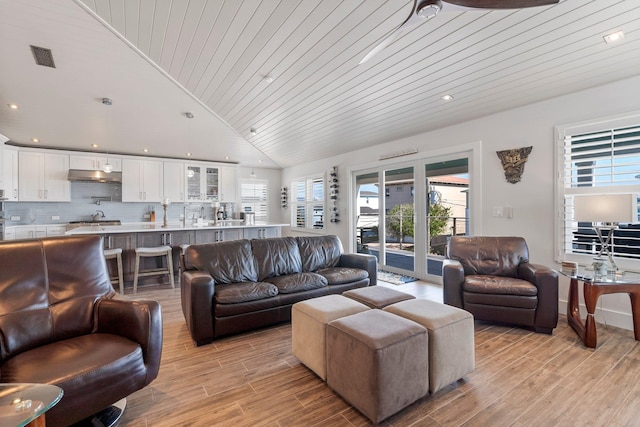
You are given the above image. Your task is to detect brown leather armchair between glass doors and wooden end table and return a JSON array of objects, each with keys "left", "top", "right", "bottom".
[{"left": 442, "top": 236, "right": 558, "bottom": 334}]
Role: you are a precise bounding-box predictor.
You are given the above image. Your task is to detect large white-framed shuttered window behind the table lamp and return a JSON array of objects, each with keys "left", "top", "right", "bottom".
[{"left": 556, "top": 116, "right": 640, "bottom": 261}]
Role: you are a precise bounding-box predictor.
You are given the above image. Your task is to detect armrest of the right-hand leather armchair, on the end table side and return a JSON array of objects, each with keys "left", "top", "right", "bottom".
[{"left": 518, "top": 263, "right": 558, "bottom": 329}]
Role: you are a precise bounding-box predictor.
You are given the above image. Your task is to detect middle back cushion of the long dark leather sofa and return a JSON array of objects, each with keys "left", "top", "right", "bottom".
[{"left": 251, "top": 237, "right": 302, "bottom": 281}]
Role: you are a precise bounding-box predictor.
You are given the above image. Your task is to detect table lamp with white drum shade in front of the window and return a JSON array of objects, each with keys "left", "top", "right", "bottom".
[{"left": 573, "top": 194, "right": 638, "bottom": 272}]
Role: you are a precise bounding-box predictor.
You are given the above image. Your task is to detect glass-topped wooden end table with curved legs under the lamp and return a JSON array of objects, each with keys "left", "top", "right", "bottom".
[{"left": 560, "top": 266, "right": 640, "bottom": 348}]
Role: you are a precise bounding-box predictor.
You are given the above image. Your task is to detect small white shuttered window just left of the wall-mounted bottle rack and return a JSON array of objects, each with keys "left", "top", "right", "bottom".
[{"left": 291, "top": 176, "right": 325, "bottom": 230}]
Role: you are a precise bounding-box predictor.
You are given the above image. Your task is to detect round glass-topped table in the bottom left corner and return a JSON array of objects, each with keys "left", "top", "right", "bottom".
[{"left": 0, "top": 383, "right": 64, "bottom": 427}]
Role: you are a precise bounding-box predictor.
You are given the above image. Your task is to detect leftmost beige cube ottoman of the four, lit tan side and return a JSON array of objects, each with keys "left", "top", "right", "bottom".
[{"left": 291, "top": 295, "right": 369, "bottom": 380}]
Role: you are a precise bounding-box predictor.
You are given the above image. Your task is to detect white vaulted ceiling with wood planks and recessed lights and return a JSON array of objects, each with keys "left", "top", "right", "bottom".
[{"left": 0, "top": 0, "right": 640, "bottom": 168}]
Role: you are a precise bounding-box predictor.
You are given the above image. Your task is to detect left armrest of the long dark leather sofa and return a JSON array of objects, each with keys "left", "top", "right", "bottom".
[{"left": 180, "top": 270, "right": 215, "bottom": 345}]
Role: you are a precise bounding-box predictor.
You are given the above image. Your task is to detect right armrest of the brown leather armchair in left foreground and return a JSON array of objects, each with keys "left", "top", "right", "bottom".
[{"left": 95, "top": 298, "right": 162, "bottom": 385}]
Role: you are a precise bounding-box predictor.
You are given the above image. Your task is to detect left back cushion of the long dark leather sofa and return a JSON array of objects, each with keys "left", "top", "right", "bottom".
[{"left": 184, "top": 240, "right": 258, "bottom": 284}]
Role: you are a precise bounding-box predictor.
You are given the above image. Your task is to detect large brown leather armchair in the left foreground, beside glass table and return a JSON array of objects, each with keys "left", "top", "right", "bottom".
[{"left": 0, "top": 235, "right": 162, "bottom": 426}]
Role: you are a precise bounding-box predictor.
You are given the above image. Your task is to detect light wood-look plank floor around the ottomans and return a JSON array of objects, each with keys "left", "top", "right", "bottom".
[{"left": 120, "top": 282, "right": 640, "bottom": 427}]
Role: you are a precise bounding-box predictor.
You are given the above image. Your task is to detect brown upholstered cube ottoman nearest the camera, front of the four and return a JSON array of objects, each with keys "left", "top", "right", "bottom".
[{"left": 327, "top": 310, "right": 429, "bottom": 423}]
